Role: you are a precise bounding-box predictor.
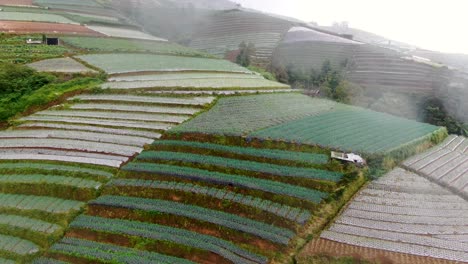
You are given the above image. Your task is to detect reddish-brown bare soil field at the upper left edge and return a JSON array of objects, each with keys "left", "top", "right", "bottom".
[{"left": 0, "top": 21, "right": 103, "bottom": 36}]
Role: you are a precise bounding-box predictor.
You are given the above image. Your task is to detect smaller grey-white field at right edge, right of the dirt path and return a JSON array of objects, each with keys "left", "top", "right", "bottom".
[{"left": 403, "top": 136, "right": 468, "bottom": 199}]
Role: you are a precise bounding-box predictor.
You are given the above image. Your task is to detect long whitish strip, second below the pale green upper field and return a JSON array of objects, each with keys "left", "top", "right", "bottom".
[{"left": 103, "top": 78, "right": 289, "bottom": 90}]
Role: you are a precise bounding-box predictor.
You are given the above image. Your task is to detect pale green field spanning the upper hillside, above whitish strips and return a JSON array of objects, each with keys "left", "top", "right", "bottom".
[{"left": 78, "top": 53, "right": 250, "bottom": 74}]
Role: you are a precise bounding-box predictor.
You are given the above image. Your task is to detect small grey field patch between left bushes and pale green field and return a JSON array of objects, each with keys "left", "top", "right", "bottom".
[{"left": 28, "top": 58, "right": 96, "bottom": 73}]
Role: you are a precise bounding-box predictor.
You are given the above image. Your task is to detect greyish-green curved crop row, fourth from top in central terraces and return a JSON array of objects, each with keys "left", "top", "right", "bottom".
[{"left": 109, "top": 179, "right": 311, "bottom": 224}]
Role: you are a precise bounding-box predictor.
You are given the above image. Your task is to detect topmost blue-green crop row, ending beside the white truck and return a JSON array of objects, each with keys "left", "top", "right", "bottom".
[{"left": 152, "top": 140, "right": 328, "bottom": 164}]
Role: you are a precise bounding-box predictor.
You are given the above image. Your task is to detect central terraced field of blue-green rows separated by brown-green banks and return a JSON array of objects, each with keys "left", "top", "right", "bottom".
[{"left": 41, "top": 140, "right": 362, "bottom": 263}]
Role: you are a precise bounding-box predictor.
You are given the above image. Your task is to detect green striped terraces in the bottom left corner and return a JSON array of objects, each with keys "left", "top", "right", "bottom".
[{"left": 0, "top": 161, "right": 114, "bottom": 263}]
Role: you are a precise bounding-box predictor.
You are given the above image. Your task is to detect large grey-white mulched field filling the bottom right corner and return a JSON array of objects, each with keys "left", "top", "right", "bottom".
[{"left": 305, "top": 168, "right": 468, "bottom": 263}]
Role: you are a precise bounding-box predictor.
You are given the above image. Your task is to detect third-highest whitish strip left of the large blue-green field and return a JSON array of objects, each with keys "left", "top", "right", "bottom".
[{"left": 35, "top": 110, "right": 190, "bottom": 124}]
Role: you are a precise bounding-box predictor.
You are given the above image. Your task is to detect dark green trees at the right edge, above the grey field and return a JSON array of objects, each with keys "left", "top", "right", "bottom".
[{"left": 424, "top": 98, "right": 468, "bottom": 136}]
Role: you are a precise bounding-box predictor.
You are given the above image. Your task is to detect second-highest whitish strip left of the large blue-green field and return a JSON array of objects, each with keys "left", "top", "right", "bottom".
[{"left": 70, "top": 103, "right": 200, "bottom": 115}]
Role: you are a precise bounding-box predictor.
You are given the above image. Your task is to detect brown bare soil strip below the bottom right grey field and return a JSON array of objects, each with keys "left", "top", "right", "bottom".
[{"left": 297, "top": 238, "right": 460, "bottom": 264}]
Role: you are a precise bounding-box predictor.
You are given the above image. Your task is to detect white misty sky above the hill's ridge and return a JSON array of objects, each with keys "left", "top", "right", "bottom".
[{"left": 233, "top": 0, "right": 468, "bottom": 54}]
